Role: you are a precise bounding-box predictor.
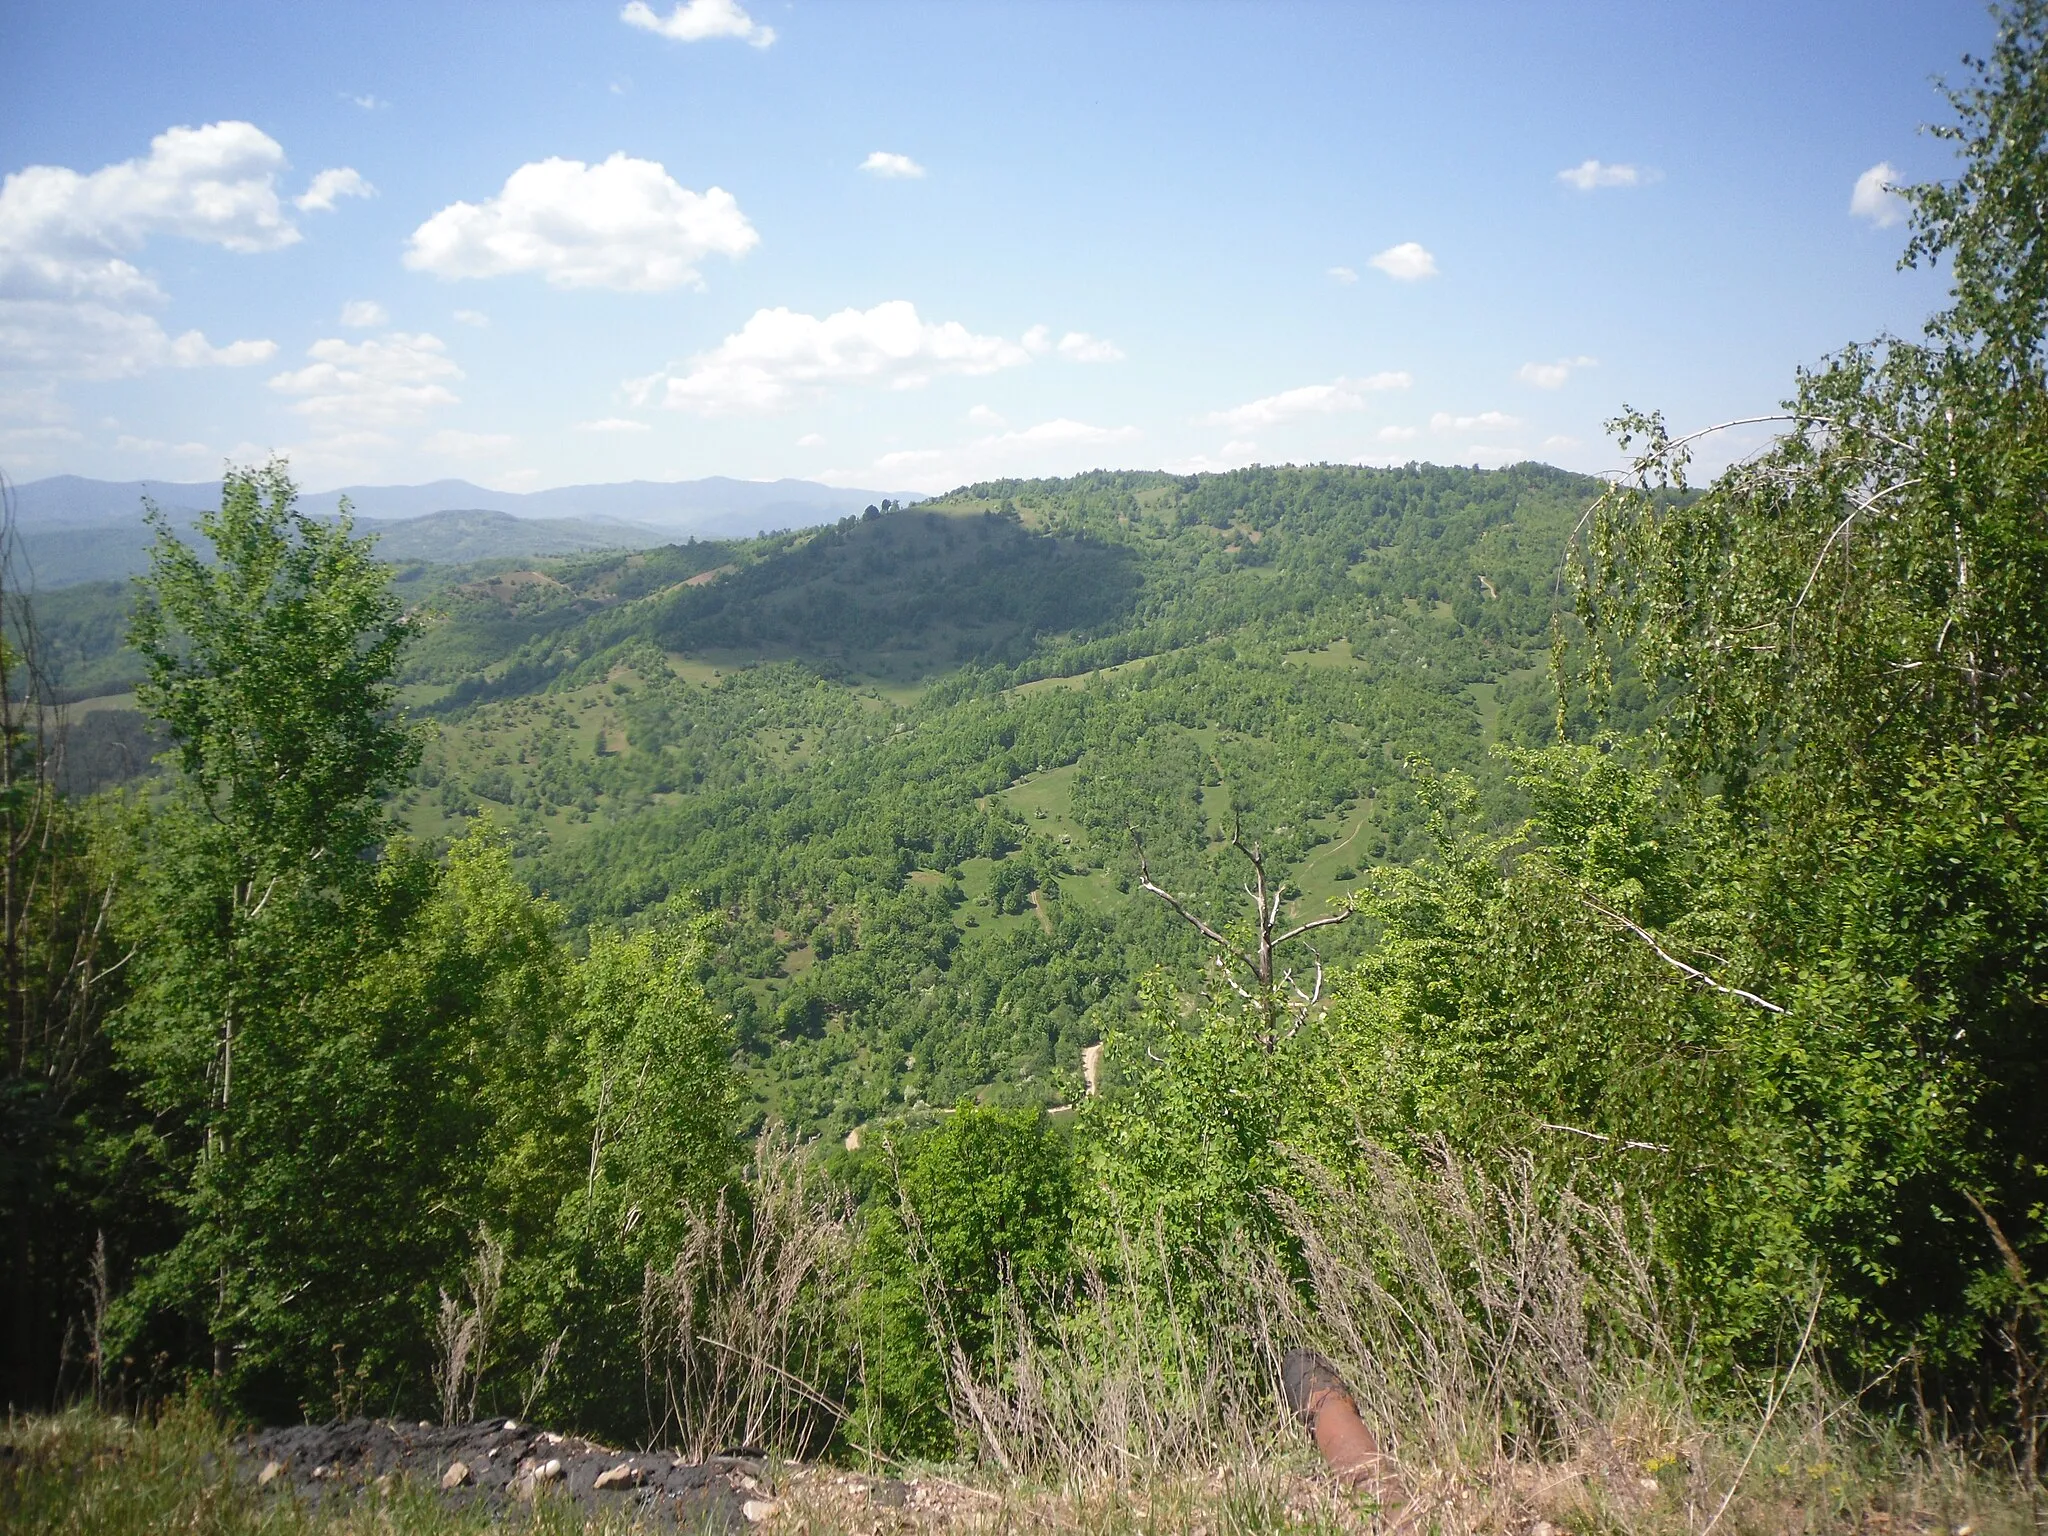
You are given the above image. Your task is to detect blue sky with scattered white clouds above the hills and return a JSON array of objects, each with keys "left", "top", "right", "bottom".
[{"left": 0, "top": 0, "right": 1991, "bottom": 489}]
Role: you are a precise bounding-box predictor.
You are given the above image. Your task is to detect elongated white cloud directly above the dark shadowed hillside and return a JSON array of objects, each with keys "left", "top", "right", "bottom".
[{"left": 629, "top": 299, "right": 1030, "bottom": 416}]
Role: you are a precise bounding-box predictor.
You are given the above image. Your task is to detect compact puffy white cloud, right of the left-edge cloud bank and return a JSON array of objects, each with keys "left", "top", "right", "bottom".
[{"left": 406, "top": 154, "right": 760, "bottom": 293}]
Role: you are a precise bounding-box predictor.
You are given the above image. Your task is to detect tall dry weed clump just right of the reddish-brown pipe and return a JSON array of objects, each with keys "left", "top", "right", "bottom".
[{"left": 1260, "top": 1143, "right": 1690, "bottom": 1460}]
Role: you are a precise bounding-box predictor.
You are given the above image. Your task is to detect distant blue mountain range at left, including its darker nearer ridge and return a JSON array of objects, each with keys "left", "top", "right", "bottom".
[{"left": 10, "top": 475, "right": 918, "bottom": 588}]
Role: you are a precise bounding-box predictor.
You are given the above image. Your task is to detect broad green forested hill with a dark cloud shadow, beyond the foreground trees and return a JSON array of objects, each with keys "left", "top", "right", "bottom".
[{"left": 368, "top": 465, "right": 1597, "bottom": 1135}]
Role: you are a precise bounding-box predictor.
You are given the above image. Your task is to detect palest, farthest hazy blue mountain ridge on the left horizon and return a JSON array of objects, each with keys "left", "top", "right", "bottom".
[{"left": 14, "top": 475, "right": 918, "bottom": 539}]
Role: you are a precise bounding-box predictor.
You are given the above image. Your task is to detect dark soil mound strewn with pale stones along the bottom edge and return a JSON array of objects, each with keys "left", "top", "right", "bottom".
[{"left": 238, "top": 1419, "right": 887, "bottom": 1530}]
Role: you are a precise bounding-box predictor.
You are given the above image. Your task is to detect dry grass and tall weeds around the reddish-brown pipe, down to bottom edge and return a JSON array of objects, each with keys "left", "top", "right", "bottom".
[{"left": 897, "top": 1149, "right": 2042, "bottom": 1536}]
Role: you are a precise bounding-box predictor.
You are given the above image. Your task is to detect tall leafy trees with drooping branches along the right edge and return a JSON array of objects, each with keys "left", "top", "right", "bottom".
[{"left": 1507, "top": 0, "right": 2048, "bottom": 1392}]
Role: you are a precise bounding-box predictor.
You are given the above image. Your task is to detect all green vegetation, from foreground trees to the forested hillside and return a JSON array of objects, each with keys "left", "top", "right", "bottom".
[{"left": 0, "top": 4, "right": 2048, "bottom": 1507}]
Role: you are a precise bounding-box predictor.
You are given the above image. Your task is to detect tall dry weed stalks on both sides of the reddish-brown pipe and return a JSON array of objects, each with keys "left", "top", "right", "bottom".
[{"left": 932, "top": 1147, "right": 1688, "bottom": 1479}]
